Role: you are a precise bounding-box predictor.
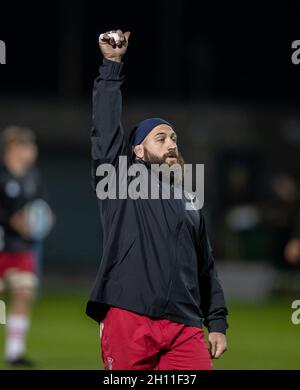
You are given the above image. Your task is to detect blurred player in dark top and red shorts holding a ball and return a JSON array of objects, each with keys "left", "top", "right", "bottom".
[{"left": 0, "top": 126, "right": 53, "bottom": 366}]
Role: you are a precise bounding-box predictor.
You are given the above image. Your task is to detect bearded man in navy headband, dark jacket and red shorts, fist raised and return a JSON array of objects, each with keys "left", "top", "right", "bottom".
[{"left": 87, "top": 30, "right": 227, "bottom": 370}]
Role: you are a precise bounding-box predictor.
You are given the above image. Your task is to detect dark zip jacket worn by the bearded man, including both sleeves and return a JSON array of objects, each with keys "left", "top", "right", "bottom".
[{"left": 86, "top": 59, "right": 227, "bottom": 333}]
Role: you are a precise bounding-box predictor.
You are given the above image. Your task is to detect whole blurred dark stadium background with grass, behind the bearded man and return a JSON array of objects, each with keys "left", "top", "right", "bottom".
[{"left": 0, "top": 0, "right": 300, "bottom": 369}]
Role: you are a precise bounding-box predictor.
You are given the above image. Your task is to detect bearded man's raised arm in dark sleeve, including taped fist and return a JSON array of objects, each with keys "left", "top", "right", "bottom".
[{"left": 91, "top": 30, "right": 130, "bottom": 188}]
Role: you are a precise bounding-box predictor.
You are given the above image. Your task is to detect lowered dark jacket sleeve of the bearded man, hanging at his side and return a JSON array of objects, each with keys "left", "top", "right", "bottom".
[{"left": 199, "top": 213, "right": 228, "bottom": 334}]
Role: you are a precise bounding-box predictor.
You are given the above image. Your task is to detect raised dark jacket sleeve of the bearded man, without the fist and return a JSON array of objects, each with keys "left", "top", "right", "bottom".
[{"left": 91, "top": 58, "right": 127, "bottom": 188}]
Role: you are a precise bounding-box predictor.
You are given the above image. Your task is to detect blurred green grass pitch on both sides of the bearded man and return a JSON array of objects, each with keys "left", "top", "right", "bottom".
[{"left": 0, "top": 292, "right": 300, "bottom": 370}]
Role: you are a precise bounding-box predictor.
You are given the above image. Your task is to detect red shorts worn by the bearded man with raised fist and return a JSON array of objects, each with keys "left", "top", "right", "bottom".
[{"left": 100, "top": 308, "right": 212, "bottom": 370}]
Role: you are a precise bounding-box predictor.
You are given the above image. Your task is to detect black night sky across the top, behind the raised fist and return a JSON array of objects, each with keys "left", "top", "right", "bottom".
[{"left": 0, "top": 0, "right": 300, "bottom": 102}]
